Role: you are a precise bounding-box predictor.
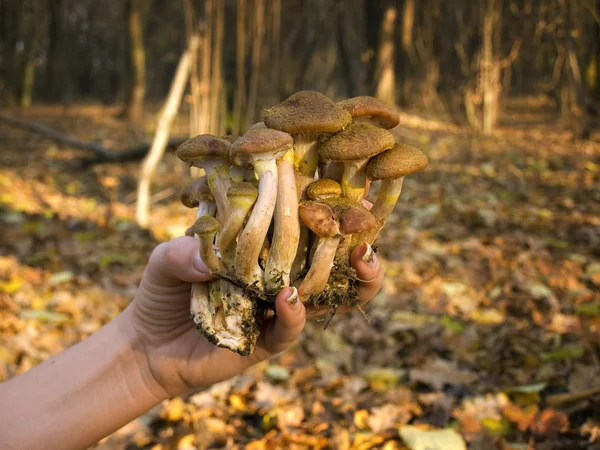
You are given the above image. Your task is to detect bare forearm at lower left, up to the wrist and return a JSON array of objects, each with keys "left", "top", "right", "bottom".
[{"left": 0, "top": 311, "right": 165, "bottom": 450}]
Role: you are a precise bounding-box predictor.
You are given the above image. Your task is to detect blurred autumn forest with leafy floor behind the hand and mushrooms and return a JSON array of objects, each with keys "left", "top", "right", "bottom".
[{"left": 0, "top": 0, "right": 600, "bottom": 450}]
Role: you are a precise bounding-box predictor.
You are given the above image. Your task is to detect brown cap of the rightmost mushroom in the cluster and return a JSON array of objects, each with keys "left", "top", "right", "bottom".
[{"left": 367, "top": 144, "right": 429, "bottom": 180}]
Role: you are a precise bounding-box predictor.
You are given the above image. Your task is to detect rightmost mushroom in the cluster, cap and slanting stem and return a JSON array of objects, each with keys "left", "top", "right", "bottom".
[{"left": 352, "top": 144, "right": 429, "bottom": 245}]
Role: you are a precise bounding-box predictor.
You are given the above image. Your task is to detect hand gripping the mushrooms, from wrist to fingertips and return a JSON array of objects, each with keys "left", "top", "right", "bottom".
[{"left": 125, "top": 237, "right": 383, "bottom": 398}]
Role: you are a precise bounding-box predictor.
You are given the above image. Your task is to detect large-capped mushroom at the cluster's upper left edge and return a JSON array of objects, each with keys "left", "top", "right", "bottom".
[{"left": 176, "top": 134, "right": 231, "bottom": 222}]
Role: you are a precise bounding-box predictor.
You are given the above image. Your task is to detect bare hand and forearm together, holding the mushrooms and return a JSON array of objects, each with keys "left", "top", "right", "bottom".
[{"left": 0, "top": 237, "right": 383, "bottom": 450}]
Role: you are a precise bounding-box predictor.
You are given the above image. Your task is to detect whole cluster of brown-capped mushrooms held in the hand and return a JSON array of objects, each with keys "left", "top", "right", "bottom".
[{"left": 177, "top": 91, "right": 428, "bottom": 355}]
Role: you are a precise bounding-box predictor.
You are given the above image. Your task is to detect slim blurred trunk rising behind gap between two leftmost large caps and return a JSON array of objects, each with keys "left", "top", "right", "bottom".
[{"left": 231, "top": 0, "right": 246, "bottom": 136}]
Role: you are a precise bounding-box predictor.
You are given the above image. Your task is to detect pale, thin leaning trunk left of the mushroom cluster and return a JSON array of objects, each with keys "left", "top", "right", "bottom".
[{"left": 136, "top": 37, "right": 199, "bottom": 228}]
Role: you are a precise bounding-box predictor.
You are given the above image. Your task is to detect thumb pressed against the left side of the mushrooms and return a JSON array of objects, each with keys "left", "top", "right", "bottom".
[{"left": 147, "top": 236, "right": 214, "bottom": 286}]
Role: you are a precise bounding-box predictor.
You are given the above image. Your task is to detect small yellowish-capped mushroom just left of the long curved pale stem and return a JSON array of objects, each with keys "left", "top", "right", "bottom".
[{"left": 219, "top": 182, "right": 258, "bottom": 274}]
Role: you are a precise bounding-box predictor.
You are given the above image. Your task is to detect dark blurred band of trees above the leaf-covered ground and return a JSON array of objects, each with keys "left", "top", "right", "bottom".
[{"left": 0, "top": 0, "right": 600, "bottom": 137}]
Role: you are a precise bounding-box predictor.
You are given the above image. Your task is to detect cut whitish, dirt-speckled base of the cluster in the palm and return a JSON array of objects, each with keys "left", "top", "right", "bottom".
[{"left": 190, "top": 278, "right": 262, "bottom": 356}]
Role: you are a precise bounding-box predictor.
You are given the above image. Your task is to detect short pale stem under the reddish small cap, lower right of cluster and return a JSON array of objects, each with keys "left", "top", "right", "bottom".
[{"left": 298, "top": 235, "right": 342, "bottom": 302}]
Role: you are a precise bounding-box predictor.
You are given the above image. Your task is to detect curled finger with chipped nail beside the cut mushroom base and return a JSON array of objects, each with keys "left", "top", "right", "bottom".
[{"left": 263, "top": 287, "right": 306, "bottom": 355}]
